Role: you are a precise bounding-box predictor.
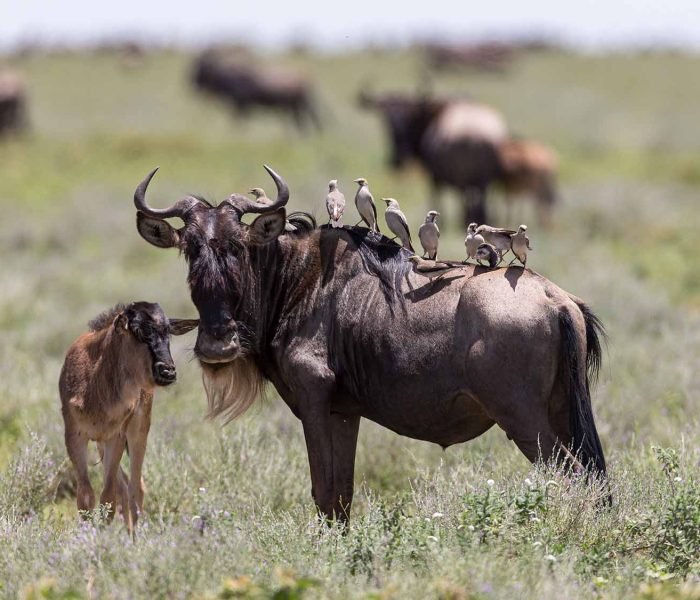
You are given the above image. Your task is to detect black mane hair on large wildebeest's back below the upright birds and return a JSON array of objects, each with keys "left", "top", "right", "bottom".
[{"left": 321, "top": 225, "right": 413, "bottom": 307}]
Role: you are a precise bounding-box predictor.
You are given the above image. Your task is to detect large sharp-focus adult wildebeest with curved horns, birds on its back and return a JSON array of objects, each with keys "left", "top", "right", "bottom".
[{"left": 134, "top": 167, "right": 605, "bottom": 519}]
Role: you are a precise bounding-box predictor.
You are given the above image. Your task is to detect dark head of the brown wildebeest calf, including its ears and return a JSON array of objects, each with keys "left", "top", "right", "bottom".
[{"left": 118, "top": 302, "right": 198, "bottom": 386}]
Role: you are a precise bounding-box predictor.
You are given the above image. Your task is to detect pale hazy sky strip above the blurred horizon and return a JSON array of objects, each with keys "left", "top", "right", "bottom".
[{"left": 0, "top": 0, "right": 700, "bottom": 49}]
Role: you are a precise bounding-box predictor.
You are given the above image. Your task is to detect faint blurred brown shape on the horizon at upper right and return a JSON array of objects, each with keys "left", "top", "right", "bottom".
[{"left": 425, "top": 41, "right": 515, "bottom": 73}]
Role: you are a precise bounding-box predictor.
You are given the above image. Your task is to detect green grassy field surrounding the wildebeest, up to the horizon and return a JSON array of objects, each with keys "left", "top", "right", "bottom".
[{"left": 0, "top": 51, "right": 700, "bottom": 599}]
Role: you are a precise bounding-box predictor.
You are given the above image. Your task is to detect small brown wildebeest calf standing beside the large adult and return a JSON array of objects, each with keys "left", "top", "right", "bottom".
[{"left": 59, "top": 302, "right": 198, "bottom": 532}]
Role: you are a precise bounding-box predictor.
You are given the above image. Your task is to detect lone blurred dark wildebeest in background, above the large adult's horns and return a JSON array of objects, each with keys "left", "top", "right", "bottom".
[{"left": 193, "top": 50, "right": 321, "bottom": 129}]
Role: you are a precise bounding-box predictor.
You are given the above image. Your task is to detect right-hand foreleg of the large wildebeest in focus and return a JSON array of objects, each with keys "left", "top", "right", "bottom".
[{"left": 331, "top": 413, "right": 360, "bottom": 522}]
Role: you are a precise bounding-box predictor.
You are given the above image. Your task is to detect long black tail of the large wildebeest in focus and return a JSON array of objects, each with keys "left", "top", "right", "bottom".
[{"left": 559, "top": 303, "right": 606, "bottom": 476}]
